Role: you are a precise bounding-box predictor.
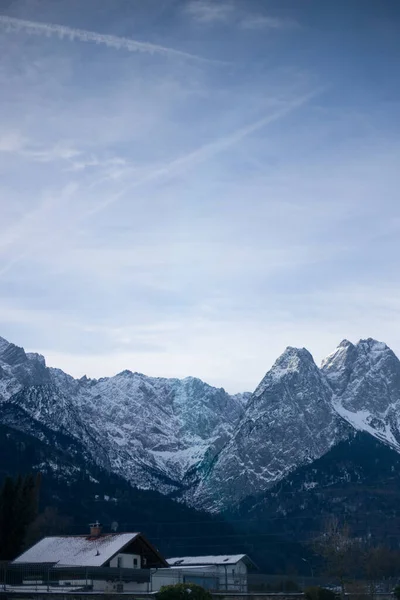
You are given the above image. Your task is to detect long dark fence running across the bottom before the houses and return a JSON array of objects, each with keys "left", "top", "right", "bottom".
[{"left": 0, "top": 562, "right": 399, "bottom": 600}]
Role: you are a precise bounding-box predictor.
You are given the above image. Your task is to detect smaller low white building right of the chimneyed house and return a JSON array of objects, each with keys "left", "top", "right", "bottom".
[{"left": 162, "top": 554, "right": 257, "bottom": 592}]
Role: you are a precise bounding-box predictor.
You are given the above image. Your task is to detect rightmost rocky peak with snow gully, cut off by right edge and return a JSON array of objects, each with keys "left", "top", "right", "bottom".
[{"left": 321, "top": 338, "right": 400, "bottom": 450}]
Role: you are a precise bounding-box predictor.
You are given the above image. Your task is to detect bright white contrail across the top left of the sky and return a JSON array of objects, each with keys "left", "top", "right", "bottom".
[{"left": 0, "top": 15, "right": 216, "bottom": 64}]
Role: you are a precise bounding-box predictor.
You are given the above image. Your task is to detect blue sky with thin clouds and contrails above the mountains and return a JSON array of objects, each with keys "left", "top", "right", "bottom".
[{"left": 0, "top": 0, "right": 400, "bottom": 392}]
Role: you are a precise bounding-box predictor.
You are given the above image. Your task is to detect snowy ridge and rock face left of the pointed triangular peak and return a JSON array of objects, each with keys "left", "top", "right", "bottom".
[{"left": 0, "top": 338, "right": 244, "bottom": 492}]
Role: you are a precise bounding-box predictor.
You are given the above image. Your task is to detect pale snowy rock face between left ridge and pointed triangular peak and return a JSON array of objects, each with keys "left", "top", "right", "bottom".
[{"left": 65, "top": 371, "right": 243, "bottom": 491}]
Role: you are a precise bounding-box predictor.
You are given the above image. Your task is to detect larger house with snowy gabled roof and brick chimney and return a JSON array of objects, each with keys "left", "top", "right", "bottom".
[{"left": 11, "top": 523, "right": 168, "bottom": 592}]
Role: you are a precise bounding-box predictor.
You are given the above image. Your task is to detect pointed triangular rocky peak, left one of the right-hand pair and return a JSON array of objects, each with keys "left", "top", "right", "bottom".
[{"left": 186, "top": 348, "right": 349, "bottom": 510}]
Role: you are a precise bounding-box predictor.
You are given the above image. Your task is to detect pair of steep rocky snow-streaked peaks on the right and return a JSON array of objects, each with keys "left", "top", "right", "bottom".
[{"left": 186, "top": 339, "right": 400, "bottom": 510}]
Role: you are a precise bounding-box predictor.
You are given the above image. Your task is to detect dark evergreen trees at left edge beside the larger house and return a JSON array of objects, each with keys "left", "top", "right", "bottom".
[{"left": 0, "top": 474, "right": 41, "bottom": 560}]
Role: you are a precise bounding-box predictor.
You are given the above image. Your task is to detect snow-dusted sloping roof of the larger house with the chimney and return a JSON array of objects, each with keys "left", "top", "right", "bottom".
[{"left": 14, "top": 533, "right": 140, "bottom": 567}]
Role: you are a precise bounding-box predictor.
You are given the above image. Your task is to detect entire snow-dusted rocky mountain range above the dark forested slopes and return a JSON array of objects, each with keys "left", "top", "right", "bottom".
[{"left": 0, "top": 338, "right": 400, "bottom": 511}]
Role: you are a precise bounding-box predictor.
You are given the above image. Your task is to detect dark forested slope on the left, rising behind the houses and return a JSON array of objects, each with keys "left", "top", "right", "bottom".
[{"left": 0, "top": 414, "right": 240, "bottom": 556}]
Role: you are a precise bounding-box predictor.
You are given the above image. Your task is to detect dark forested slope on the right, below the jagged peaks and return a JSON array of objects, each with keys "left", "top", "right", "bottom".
[{"left": 231, "top": 431, "right": 400, "bottom": 548}]
